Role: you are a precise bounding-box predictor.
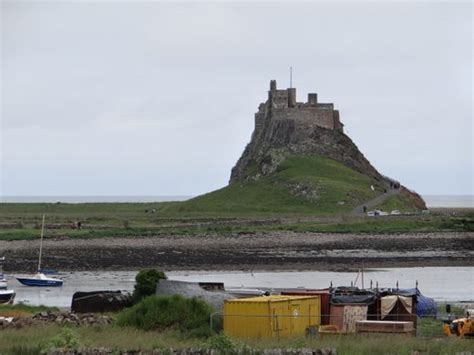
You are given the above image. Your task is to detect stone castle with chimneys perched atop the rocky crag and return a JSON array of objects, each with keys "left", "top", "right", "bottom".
[{"left": 255, "top": 80, "right": 344, "bottom": 132}]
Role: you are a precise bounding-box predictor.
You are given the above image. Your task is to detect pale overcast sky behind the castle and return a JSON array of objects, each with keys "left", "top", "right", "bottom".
[{"left": 0, "top": 0, "right": 474, "bottom": 196}]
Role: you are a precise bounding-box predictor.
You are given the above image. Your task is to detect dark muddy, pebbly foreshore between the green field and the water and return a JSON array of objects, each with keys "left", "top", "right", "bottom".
[{"left": 0, "top": 232, "right": 474, "bottom": 272}]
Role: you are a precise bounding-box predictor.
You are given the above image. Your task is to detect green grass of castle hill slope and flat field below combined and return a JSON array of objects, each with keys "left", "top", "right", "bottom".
[{"left": 0, "top": 156, "right": 468, "bottom": 240}]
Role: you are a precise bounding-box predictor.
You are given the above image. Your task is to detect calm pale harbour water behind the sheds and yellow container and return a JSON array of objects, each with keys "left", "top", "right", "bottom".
[{"left": 8, "top": 267, "right": 474, "bottom": 308}]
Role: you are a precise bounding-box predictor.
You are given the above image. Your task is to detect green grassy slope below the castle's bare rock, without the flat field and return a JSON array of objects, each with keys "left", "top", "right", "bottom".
[{"left": 159, "top": 155, "right": 383, "bottom": 216}]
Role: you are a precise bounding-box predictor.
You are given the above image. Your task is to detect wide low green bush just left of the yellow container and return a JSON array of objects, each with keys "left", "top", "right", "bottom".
[{"left": 117, "top": 295, "right": 213, "bottom": 337}]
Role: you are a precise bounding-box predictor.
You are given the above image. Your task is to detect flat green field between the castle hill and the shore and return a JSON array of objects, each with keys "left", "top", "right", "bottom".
[{"left": 0, "top": 200, "right": 474, "bottom": 240}]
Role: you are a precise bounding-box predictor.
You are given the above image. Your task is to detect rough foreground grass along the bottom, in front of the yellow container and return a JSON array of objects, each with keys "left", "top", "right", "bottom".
[{"left": 0, "top": 325, "right": 472, "bottom": 355}]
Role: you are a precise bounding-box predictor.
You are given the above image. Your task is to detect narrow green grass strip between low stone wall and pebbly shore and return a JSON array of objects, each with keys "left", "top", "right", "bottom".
[{"left": 0, "top": 216, "right": 474, "bottom": 240}]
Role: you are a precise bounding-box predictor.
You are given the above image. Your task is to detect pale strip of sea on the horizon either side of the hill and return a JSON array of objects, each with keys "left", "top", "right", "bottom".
[{"left": 0, "top": 195, "right": 474, "bottom": 208}]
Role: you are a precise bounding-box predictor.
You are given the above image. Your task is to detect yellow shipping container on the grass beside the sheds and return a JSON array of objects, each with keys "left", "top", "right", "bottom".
[{"left": 224, "top": 296, "right": 321, "bottom": 339}]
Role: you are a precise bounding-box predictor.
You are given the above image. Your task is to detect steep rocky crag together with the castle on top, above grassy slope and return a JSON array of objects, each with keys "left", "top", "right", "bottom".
[{"left": 229, "top": 81, "right": 426, "bottom": 209}]
